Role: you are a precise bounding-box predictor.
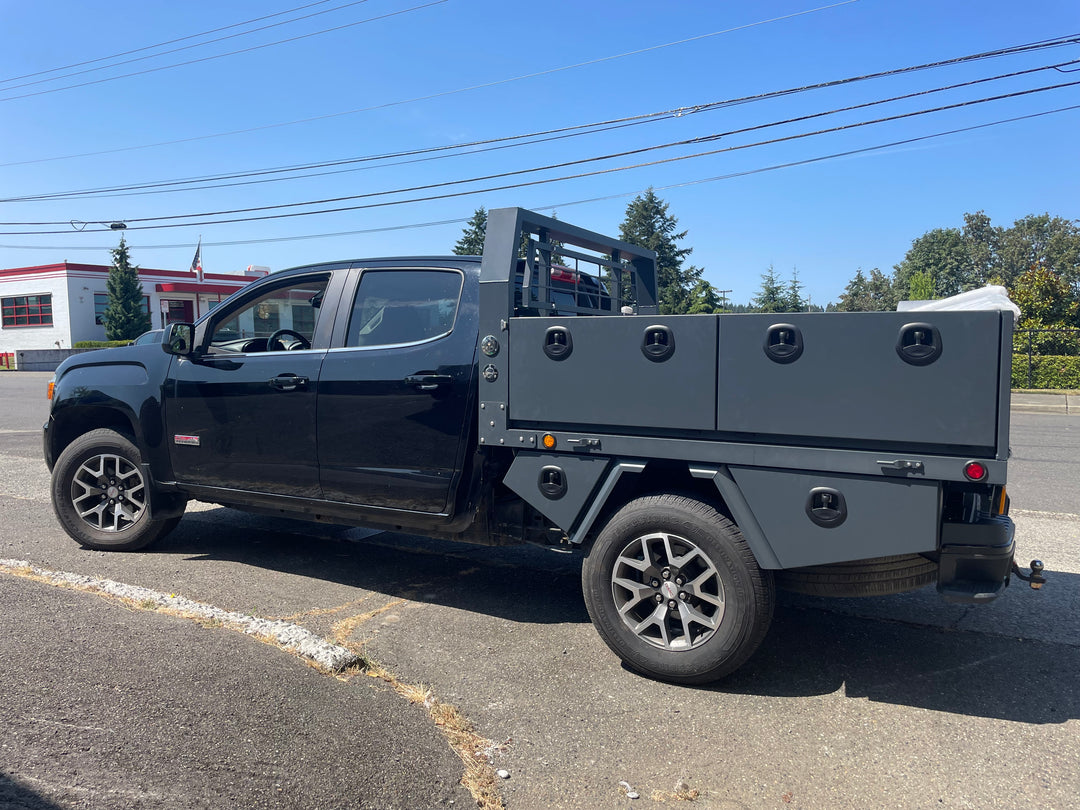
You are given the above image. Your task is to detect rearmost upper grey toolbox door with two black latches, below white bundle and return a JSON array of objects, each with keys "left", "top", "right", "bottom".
[{"left": 717, "top": 311, "right": 1011, "bottom": 449}]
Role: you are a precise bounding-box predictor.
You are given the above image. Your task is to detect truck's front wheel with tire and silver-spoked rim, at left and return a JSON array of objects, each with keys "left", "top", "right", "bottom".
[{"left": 52, "top": 429, "right": 180, "bottom": 551}]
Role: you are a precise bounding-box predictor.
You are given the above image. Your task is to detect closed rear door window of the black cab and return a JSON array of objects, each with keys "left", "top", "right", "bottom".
[{"left": 346, "top": 270, "right": 463, "bottom": 347}]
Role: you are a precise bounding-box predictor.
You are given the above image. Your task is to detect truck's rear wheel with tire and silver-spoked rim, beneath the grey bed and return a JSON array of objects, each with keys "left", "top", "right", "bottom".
[{"left": 581, "top": 494, "right": 775, "bottom": 684}]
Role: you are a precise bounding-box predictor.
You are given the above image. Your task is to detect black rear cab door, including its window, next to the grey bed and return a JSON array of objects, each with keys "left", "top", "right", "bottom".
[{"left": 318, "top": 268, "right": 476, "bottom": 514}]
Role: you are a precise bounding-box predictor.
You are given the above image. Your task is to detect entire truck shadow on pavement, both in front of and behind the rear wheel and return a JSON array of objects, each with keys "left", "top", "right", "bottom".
[{"left": 152, "top": 510, "right": 1080, "bottom": 724}]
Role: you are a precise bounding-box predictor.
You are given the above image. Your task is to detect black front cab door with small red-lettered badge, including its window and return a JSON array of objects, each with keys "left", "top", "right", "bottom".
[{"left": 165, "top": 273, "right": 329, "bottom": 498}]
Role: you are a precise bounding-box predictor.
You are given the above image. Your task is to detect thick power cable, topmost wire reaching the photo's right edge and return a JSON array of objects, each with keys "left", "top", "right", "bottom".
[{"left": 10, "top": 36, "right": 1080, "bottom": 202}]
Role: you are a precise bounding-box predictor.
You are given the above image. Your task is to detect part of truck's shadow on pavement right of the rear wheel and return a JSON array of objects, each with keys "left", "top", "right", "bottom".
[{"left": 713, "top": 600, "right": 1080, "bottom": 724}]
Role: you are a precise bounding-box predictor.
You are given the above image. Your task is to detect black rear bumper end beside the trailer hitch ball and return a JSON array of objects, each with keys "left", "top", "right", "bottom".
[{"left": 937, "top": 515, "right": 1016, "bottom": 604}]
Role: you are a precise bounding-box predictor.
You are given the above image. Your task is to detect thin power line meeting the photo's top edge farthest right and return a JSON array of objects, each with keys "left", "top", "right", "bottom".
[{"left": 0, "top": 0, "right": 858, "bottom": 167}]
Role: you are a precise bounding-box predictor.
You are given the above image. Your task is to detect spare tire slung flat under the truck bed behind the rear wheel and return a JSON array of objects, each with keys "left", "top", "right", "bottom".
[{"left": 777, "top": 554, "right": 937, "bottom": 596}]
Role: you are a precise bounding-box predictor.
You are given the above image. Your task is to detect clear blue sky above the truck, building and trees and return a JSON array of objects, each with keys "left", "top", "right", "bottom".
[{"left": 0, "top": 0, "right": 1080, "bottom": 305}]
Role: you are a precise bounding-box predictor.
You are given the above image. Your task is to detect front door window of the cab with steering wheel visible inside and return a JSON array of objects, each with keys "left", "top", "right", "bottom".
[{"left": 210, "top": 276, "right": 329, "bottom": 352}]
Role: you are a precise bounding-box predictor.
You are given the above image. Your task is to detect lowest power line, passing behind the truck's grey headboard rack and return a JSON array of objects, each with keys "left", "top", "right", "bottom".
[{"left": 0, "top": 105, "right": 1080, "bottom": 251}]
